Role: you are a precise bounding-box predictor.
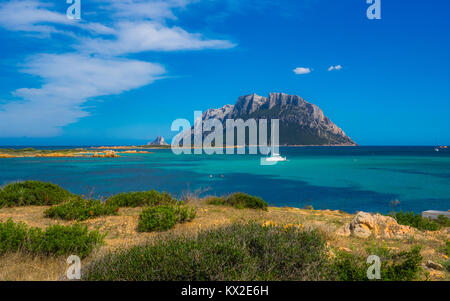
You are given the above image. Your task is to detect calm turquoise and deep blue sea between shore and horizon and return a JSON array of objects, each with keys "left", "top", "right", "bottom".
[{"left": 0, "top": 147, "right": 450, "bottom": 213}]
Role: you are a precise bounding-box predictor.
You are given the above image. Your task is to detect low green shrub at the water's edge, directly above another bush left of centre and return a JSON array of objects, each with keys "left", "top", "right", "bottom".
[{"left": 106, "top": 190, "right": 177, "bottom": 207}]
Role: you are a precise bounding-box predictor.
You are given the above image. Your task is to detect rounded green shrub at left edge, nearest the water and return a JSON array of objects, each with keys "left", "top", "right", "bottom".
[{"left": 0, "top": 181, "right": 75, "bottom": 208}]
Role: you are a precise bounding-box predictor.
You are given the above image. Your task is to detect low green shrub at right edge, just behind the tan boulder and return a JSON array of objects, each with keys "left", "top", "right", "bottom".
[{"left": 390, "top": 211, "right": 450, "bottom": 231}]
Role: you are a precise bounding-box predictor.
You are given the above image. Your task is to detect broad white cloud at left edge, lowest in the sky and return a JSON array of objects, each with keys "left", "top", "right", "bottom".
[{"left": 0, "top": 54, "right": 166, "bottom": 137}]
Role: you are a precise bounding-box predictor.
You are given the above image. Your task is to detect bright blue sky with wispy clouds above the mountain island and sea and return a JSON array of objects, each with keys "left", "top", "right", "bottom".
[{"left": 0, "top": 0, "right": 450, "bottom": 145}]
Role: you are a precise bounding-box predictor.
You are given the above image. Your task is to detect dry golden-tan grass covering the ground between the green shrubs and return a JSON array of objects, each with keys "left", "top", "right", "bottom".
[{"left": 0, "top": 198, "right": 450, "bottom": 280}]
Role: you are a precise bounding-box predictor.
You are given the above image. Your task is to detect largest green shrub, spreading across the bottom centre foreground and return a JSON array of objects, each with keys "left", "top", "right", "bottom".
[{"left": 85, "top": 224, "right": 326, "bottom": 281}]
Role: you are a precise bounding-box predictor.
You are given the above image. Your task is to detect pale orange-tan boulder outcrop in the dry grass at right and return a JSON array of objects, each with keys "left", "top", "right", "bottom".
[{"left": 336, "top": 212, "right": 414, "bottom": 238}]
